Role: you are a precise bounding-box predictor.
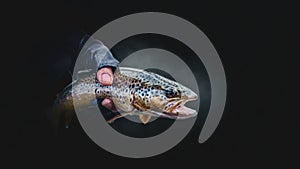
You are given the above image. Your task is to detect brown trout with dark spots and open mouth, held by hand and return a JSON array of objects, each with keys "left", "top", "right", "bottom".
[{"left": 49, "top": 67, "right": 198, "bottom": 127}]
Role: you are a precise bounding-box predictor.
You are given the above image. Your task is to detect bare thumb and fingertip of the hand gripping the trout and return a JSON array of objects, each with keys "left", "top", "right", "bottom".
[{"left": 97, "top": 67, "right": 117, "bottom": 112}]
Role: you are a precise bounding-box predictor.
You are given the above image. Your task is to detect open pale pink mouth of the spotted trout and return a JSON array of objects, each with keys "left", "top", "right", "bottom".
[{"left": 161, "top": 99, "right": 197, "bottom": 119}]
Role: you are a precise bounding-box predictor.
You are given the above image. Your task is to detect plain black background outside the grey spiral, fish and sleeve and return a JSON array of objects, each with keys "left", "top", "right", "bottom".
[{"left": 2, "top": 0, "right": 299, "bottom": 168}]
